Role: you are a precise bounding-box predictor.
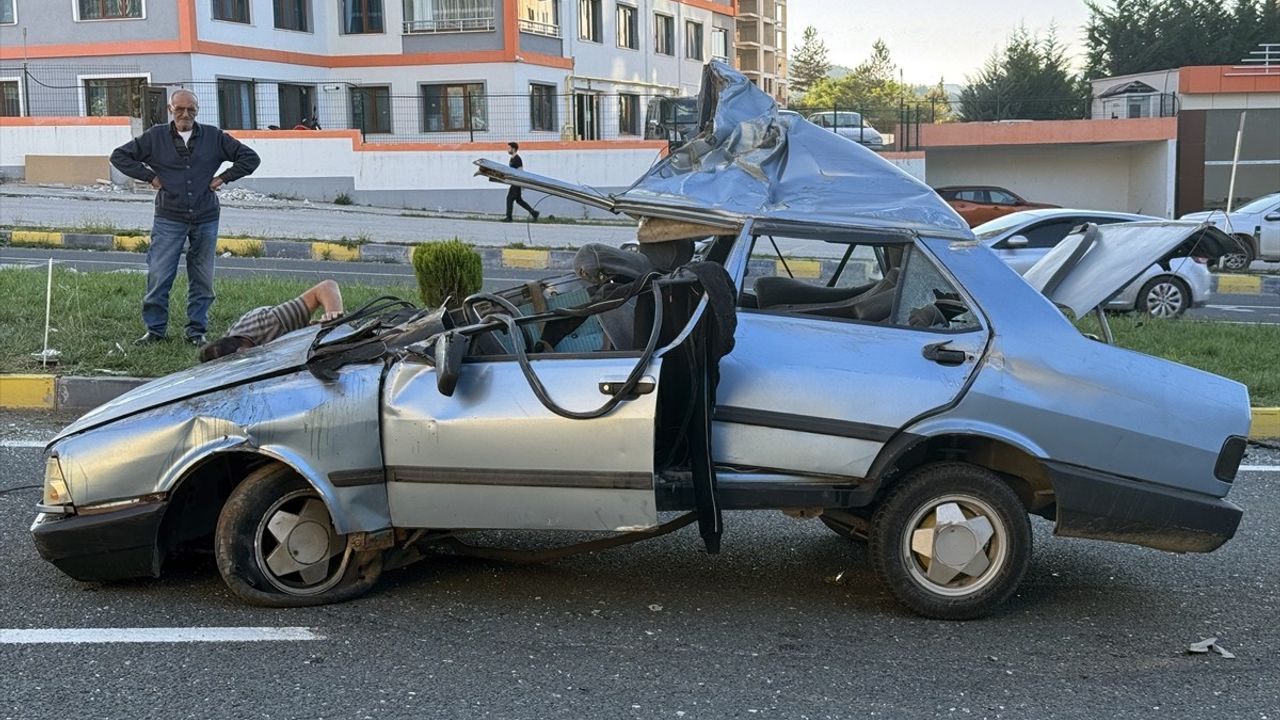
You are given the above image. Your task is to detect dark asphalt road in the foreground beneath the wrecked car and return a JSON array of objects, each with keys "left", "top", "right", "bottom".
[{"left": 0, "top": 413, "right": 1280, "bottom": 720}]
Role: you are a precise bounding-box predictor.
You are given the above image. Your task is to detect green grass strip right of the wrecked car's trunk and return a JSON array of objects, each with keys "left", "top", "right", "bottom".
[{"left": 1078, "top": 315, "right": 1280, "bottom": 406}]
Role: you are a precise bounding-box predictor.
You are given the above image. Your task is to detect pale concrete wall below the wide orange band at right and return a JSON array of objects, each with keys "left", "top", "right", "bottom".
[{"left": 927, "top": 140, "right": 1175, "bottom": 218}]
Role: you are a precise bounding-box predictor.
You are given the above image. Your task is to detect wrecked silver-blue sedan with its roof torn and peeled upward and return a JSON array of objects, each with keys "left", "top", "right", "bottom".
[{"left": 32, "top": 63, "right": 1249, "bottom": 619}]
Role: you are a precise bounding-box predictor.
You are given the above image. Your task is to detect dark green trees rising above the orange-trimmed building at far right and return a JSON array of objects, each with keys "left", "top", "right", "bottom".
[{"left": 1084, "top": 0, "right": 1280, "bottom": 78}]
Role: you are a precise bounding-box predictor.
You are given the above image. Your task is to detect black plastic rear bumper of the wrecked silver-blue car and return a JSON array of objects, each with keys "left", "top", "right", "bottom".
[{"left": 1047, "top": 462, "right": 1244, "bottom": 552}]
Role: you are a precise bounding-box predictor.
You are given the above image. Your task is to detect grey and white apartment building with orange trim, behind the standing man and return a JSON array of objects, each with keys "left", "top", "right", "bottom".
[{"left": 0, "top": 0, "right": 736, "bottom": 143}]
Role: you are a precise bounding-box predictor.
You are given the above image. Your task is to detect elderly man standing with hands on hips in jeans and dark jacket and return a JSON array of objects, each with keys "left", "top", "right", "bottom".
[{"left": 111, "top": 90, "right": 260, "bottom": 346}]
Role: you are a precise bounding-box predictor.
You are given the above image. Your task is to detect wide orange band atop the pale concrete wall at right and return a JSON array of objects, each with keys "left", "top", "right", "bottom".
[{"left": 920, "top": 118, "right": 1178, "bottom": 150}]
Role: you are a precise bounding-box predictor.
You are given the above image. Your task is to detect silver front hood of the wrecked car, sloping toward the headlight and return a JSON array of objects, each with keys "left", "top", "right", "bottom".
[{"left": 54, "top": 325, "right": 319, "bottom": 442}]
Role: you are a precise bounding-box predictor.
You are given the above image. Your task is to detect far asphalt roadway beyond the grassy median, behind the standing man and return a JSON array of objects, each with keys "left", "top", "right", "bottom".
[{"left": 0, "top": 247, "right": 1280, "bottom": 324}]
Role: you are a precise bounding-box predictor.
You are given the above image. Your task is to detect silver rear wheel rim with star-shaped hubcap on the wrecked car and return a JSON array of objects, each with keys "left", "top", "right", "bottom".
[{"left": 902, "top": 495, "right": 1009, "bottom": 597}]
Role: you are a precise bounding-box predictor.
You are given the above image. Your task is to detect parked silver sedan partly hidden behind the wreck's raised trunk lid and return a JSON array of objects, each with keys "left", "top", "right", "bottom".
[{"left": 973, "top": 209, "right": 1213, "bottom": 318}]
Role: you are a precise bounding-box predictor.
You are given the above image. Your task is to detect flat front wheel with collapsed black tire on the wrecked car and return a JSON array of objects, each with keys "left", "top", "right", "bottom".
[{"left": 214, "top": 465, "right": 383, "bottom": 607}]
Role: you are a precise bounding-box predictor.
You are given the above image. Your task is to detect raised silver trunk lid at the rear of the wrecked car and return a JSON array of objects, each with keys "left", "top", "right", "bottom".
[{"left": 1023, "top": 220, "right": 1235, "bottom": 318}]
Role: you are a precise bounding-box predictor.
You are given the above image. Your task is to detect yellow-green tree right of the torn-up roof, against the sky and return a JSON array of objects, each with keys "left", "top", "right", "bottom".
[{"left": 805, "top": 40, "right": 911, "bottom": 128}]
